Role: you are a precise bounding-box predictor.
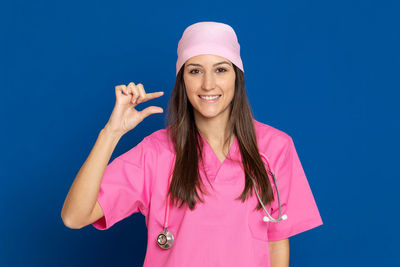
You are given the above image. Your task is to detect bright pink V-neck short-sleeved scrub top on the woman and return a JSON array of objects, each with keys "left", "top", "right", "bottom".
[{"left": 92, "top": 120, "right": 323, "bottom": 267}]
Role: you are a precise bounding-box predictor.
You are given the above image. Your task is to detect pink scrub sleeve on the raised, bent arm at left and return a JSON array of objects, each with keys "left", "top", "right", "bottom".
[{"left": 92, "top": 138, "right": 154, "bottom": 230}]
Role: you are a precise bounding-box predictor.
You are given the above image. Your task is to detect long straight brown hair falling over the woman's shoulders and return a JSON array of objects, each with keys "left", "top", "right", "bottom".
[{"left": 167, "top": 64, "right": 274, "bottom": 210}]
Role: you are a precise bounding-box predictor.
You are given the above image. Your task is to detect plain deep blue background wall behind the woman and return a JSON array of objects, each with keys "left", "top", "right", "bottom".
[{"left": 0, "top": 0, "right": 400, "bottom": 266}]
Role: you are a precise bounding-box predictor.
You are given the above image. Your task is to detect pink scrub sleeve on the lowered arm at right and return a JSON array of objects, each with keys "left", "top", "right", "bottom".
[{"left": 268, "top": 137, "right": 323, "bottom": 241}]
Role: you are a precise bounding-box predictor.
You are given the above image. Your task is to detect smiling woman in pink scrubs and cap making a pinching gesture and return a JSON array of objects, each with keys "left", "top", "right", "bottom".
[{"left": 62, "top": 22, "right": 322, "bottom": 267}]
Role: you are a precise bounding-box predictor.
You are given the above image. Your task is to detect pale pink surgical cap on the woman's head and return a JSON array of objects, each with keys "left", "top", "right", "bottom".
[{"left": 176, "top": 21, "right": 244, "bottom": 75}]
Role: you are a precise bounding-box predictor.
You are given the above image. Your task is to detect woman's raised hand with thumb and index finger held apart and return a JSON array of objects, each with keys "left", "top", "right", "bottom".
[{"left": 106, "top": 82, "right": 164, "bottom": 136}]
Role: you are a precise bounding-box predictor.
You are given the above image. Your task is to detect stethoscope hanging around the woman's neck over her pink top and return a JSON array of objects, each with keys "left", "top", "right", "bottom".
[{"left": 157, "top": 153, "right": 287, "bottom": 249}]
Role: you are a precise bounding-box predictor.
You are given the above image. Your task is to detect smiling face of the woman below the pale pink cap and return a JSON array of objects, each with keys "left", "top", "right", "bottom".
[{"left": 183, "top": 55, "right": 236, "bottom": 121}]
